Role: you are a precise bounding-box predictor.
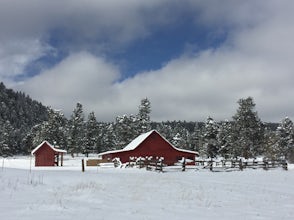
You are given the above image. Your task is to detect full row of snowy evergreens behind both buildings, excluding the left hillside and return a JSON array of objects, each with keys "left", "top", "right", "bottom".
[{"left": 25, "top": 97, "right": 294, "bottom": 161}]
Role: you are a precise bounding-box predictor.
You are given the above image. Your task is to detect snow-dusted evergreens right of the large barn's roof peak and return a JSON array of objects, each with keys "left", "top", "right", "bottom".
[{"left": 153, "top": 97, "right": 294, "bottom": 162}]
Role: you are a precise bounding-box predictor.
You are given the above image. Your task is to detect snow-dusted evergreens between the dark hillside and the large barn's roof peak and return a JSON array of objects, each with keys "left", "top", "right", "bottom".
[{"left": 27, "top": 98, "right": 151, "bottom": 156}]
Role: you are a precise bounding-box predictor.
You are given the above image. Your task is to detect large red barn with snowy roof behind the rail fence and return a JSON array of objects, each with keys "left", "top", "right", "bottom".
[{"left": 99, "top": 130, "right": 198, "bottom": 165}]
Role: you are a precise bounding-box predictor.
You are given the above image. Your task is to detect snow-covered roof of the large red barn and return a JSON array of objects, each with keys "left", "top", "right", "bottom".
[{"left": 99, "top": 130, "right": 198, "bottom": 156}]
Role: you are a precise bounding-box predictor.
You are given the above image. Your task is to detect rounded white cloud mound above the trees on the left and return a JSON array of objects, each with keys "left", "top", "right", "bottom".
[{"left": 19, "top": 52, "right": 119, "bottom": 117}]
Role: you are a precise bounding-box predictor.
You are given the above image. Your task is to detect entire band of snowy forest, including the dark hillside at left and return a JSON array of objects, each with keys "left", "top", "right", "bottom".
[{"left": 0, "top": 83, "right": 294, "bottom": 162}]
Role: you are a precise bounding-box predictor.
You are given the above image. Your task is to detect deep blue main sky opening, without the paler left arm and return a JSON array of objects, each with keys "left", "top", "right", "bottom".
[{"left": 115, "top": 19, "right": 225, "bottom": 77}]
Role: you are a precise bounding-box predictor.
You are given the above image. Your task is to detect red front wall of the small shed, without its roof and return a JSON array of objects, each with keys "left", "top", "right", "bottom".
[{"left": 35, "top": 143, "right": 55, "bottom": 166}]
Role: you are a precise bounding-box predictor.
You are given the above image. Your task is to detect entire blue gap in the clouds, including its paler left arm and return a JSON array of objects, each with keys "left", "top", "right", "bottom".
[{"left": 24, "top": 9, "right": 226, "bottom": 80}]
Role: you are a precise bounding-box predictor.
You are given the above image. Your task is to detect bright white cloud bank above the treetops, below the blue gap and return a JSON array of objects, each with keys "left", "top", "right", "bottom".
[{"left": 17, "top": 40, "right": 294, "bottom": 121}]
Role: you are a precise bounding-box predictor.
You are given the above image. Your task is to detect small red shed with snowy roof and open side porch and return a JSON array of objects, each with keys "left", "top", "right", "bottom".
[{"left": 32, "top": 141, "right": 66, "bottom": 166}]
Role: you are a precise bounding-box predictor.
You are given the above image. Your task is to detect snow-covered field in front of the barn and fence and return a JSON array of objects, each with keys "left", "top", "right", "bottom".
[{"left": 0, "top": 158, "right": 294, "bottom": 220}]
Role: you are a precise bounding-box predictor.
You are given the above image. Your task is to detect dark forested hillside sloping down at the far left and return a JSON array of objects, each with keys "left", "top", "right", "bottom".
[{"left": 0, "top": 82, "right": 48, "bottom": 156}]
